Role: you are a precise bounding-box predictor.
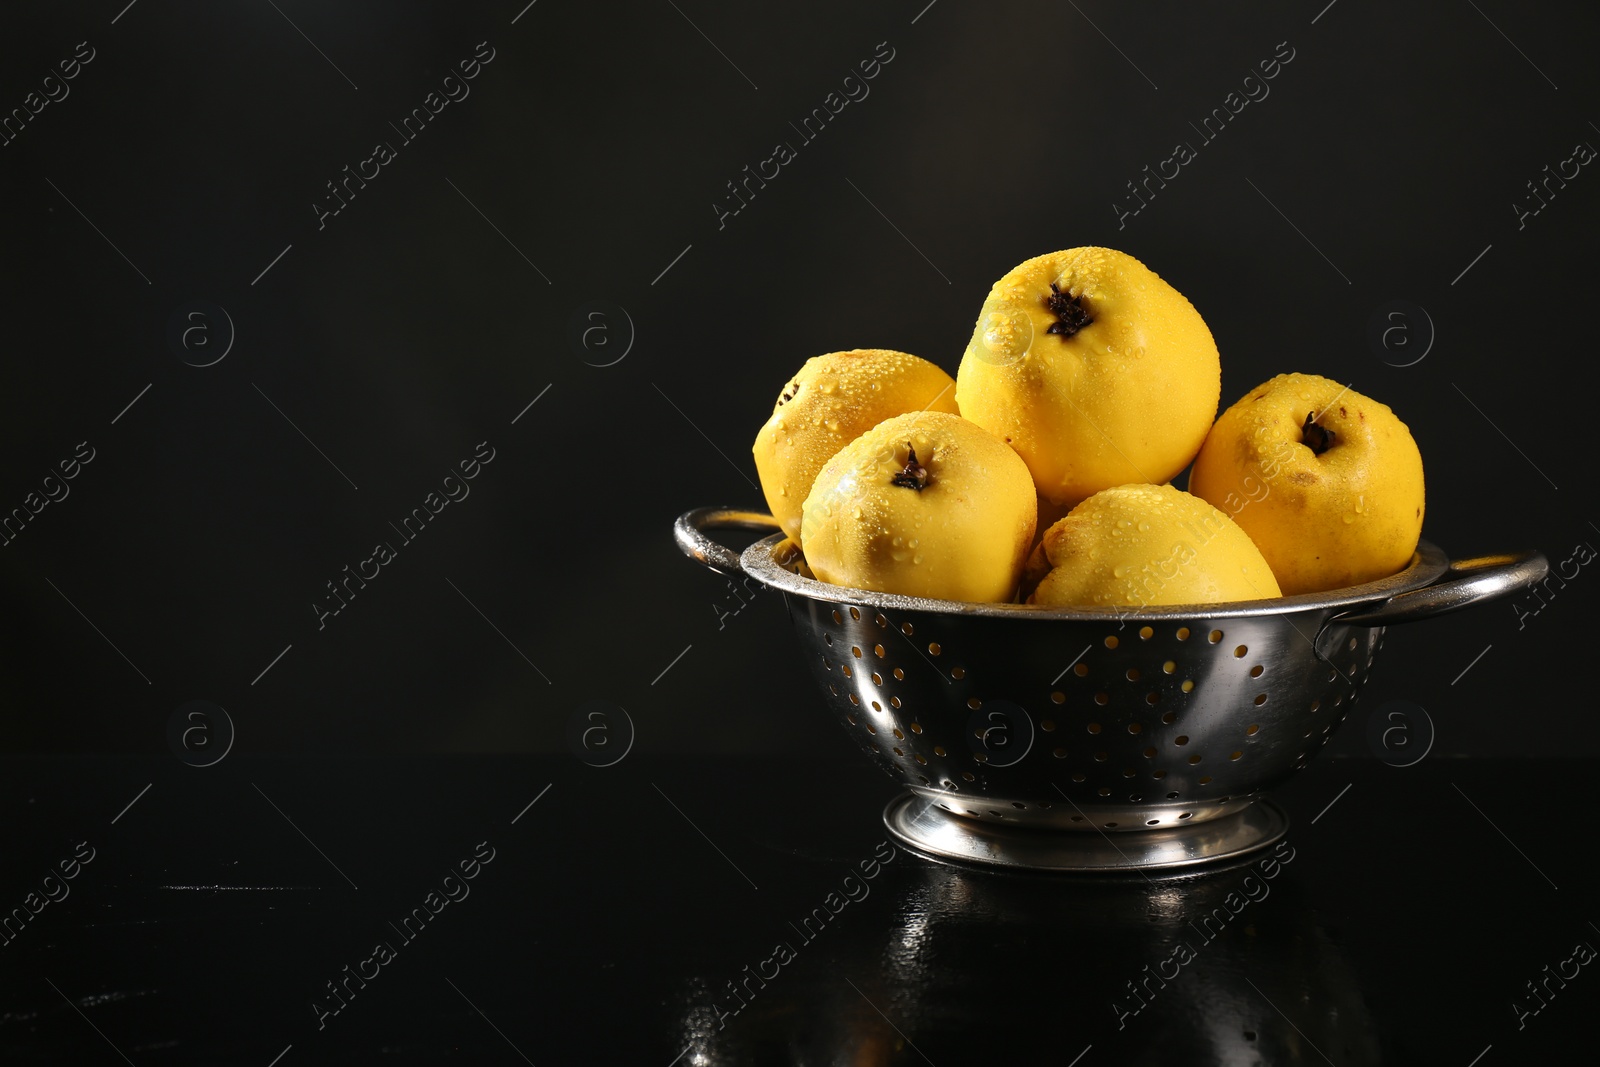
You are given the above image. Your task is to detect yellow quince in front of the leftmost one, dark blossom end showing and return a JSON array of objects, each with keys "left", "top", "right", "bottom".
[{"left": 802, "top": 411, "right": 1035, "bottom": 603}]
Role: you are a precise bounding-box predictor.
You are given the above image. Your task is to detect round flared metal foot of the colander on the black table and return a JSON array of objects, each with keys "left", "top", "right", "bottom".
[{"left": 883, "top": 793, "right": 1290, "bottom": 873}]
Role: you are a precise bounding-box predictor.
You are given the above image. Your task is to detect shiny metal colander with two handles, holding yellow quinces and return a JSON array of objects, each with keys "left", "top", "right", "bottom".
[{"left": 675, "top": 507, "right": 1547, "bottom": 870}]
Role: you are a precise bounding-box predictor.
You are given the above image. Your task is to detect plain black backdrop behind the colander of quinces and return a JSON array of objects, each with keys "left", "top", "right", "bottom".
[{"left": 0, "top": 0, "right": 1600, "bottom": 758}]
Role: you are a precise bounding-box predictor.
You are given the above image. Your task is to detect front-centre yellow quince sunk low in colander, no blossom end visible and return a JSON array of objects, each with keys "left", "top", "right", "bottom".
[{"left": 1027, "top": 485, "right": 1282, "bottom": 608}]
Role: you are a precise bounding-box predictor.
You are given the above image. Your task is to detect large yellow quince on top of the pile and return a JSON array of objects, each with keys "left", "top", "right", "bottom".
[{"left": 955, "top": 248, "right": 1222, "bottom": 507}]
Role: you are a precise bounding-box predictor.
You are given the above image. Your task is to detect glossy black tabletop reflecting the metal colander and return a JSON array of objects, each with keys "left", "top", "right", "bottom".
[{"left": 0, "top": 755, "right": 1600, "bottom": 1067}]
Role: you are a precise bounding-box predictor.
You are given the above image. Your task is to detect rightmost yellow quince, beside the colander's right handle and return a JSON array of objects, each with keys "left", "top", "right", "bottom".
[{"left": 1189, "top": 374, "right": 1424, "bottom": 593}]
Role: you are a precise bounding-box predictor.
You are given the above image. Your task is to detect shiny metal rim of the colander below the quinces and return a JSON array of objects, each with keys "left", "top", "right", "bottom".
[{"left": 739, "top": 533, "right": 1450, "bottom": 622}]
